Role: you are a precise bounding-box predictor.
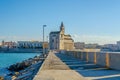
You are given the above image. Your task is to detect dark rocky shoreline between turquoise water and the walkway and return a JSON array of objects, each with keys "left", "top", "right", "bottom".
[{"left": 0, "top": 55, "right": 45, "bottom": 80}]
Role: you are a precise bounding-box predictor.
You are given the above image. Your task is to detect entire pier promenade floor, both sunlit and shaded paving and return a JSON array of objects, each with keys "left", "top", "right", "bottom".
[{"left": 34, "top": 52, "right": 120, "bottom": 80}]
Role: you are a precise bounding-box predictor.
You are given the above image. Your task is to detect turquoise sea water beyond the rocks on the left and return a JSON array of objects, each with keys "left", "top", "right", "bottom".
[{"left": 0, "top": 53, "right": 41, "bottom": 68}]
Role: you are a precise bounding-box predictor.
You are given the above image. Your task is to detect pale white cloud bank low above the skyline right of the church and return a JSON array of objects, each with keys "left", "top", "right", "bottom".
[{"left": 72, "top": 34, "right": 120, "bottom": 44}]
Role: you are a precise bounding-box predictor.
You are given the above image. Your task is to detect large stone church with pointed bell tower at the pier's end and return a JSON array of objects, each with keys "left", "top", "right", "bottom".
[{"left": 49, "top": 22, "right": 74, "bottom": 50}]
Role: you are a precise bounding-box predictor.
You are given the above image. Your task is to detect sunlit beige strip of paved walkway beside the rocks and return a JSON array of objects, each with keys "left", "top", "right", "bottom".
[{"left": 34, "top": 53, "right": 86, "bottom": 80}]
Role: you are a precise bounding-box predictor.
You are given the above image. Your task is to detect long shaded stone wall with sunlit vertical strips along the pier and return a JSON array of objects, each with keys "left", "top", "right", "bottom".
[{"left": 65, "top": 51, "right": 120, "bottom": 70}]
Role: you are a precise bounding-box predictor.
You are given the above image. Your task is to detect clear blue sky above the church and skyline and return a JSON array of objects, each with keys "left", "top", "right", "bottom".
[{"left": 0, "top": 0, "right": 120, "bottom": 44}]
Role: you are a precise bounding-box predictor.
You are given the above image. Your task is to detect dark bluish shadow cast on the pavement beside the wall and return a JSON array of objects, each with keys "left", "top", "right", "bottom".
[{"left": 56, "top": 53, "right": 120, "bottom": 80}]
